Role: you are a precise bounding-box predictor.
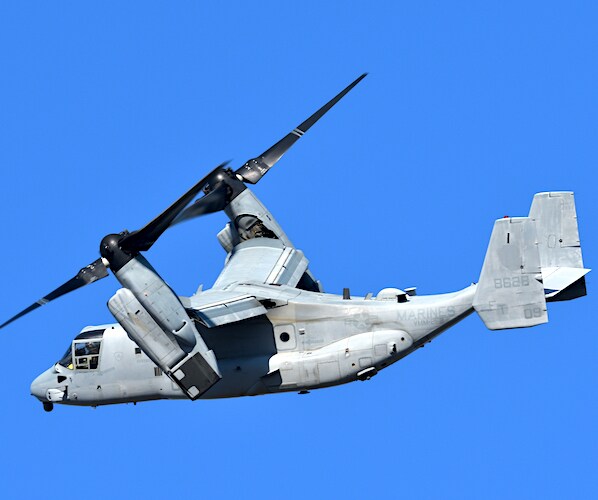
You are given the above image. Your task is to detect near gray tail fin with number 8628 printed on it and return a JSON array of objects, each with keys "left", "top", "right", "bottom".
[{"left": 473, "top": 217, "right": 548, "bottom": 330}]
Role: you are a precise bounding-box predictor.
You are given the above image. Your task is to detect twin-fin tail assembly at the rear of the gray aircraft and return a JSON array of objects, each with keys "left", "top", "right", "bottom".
[{"left": 473, "top": 192, "right": 590, "bottom": 330}]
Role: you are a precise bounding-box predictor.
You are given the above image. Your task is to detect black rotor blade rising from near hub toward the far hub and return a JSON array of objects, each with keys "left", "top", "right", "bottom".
[{"left": 118, "top": 162, "right": 229, "bottom": 252}]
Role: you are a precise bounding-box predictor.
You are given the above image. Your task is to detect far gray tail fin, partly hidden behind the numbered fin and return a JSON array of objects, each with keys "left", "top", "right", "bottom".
[{"left": 529, "top": 191, "right": 590, "bottom": 301}]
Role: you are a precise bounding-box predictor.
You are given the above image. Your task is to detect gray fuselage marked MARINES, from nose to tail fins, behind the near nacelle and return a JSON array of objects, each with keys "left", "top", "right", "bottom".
[{"left": 31, "top": 285, "right": 475, "bottom": 406}]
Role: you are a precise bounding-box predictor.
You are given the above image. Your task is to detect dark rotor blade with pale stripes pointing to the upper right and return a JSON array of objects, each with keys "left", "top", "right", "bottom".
[{"left": 235, "top": 73, "right": 367, "bottom": 184}]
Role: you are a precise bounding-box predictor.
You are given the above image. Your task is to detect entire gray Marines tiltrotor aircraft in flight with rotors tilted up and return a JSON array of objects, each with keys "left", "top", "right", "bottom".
[{"left": 0, "top": 74, "right": 589, "bottom": 411}]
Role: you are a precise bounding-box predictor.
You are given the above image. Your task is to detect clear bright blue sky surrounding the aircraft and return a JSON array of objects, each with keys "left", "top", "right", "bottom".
[{"left": 0, "top": 1, "right": 598, "bottom": 499}]
